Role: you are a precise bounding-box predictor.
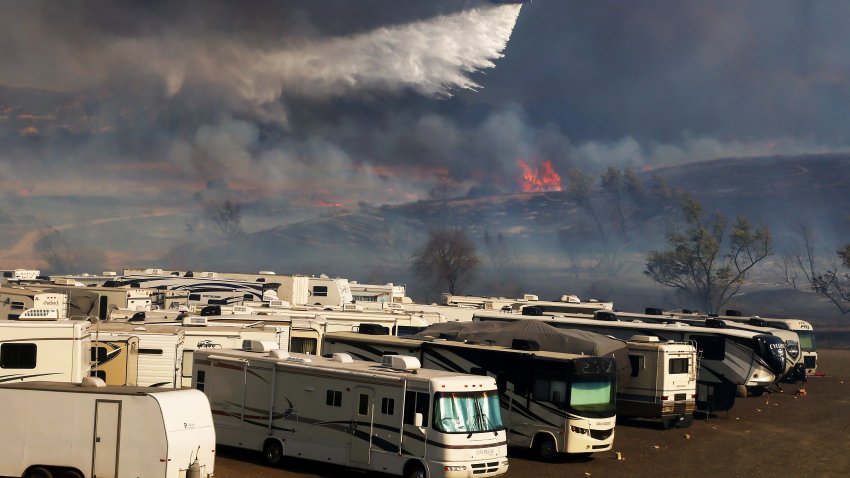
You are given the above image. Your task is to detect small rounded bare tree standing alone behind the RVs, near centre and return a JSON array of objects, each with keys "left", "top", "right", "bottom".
[{"left": 413, "top": 229, "right": 481, "bottom": 294}]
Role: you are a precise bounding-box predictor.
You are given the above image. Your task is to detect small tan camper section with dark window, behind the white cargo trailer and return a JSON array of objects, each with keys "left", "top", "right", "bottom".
[{"left": 90, "top": 336, "right": 139, "bottom": 386}]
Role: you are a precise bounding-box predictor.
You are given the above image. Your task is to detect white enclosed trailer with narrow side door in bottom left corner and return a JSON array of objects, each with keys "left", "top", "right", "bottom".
[{"left": 0, "top": 377, "right": 215, "bottom": 478}]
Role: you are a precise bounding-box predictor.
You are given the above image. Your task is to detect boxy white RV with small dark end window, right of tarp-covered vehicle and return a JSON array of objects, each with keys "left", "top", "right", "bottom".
[{"left": 617, "top": 335, "right": 699, "bottom": 429}]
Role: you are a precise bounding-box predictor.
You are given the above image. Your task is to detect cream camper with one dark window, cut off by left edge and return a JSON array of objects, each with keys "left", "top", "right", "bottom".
[{"left": 0, "top": 320, "right": 91, "bottom": 383}]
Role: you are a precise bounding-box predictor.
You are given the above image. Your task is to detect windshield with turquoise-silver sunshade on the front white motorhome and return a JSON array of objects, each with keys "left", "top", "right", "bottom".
[{"left": 434, "top": 390, "right": 502, "bottom": 433}]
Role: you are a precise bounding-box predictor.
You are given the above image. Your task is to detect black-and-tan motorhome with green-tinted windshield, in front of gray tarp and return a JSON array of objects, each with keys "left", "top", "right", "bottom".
[{"left": 323, "top": 329, "right": 617, "bottom": 460}]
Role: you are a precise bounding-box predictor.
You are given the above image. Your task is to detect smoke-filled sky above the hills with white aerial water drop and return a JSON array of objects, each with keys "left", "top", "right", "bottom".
[{"left": 0, "top": 0, "right": 850, "bottom": 262}]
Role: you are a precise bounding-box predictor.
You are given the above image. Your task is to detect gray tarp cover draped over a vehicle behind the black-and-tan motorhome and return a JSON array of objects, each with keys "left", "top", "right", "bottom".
[{"left": 414, "top": 320, "right": 632, "bottom": 388}]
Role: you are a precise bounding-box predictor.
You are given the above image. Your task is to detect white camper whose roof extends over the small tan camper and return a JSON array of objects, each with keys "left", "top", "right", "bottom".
[{"left": 92, "top": 322, "right": 184, "bottom": 388}]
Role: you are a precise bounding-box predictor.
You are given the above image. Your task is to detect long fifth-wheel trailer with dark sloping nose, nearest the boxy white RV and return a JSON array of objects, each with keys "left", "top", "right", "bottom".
[{"left": 474, "top": 311, "right": 785, "bottom": 411}]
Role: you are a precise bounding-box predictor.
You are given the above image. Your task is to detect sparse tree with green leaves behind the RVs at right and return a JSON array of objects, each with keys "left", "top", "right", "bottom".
[{"left": 644, "top": 198, "right": 773, "bottom": 313}]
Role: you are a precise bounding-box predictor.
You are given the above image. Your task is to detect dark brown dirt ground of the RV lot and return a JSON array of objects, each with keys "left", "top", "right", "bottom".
[{"left": 210, "top": 350, "right": 850, "bottom": 478}]
